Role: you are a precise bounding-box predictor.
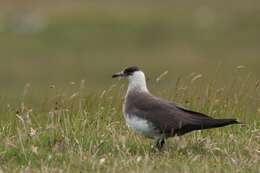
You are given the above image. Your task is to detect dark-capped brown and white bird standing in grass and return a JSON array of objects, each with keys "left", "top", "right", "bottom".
[{"left": 112, "top": 66, "right": 240, "bottom": 150}]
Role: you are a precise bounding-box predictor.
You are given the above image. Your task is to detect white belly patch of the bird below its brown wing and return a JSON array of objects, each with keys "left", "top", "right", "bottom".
[{"left": 125, "top": 115, "right": 158, "bottom": 138}]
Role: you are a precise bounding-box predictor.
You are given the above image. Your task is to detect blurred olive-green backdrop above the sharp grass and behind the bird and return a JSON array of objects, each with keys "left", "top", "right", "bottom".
[{"left": 0, "top": 0, "right": 260, "bottom": 97}]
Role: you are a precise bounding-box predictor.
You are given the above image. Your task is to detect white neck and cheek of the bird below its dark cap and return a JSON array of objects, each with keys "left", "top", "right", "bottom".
[{"left": 127, "top": 71, "right": 149, "bottom": 93}]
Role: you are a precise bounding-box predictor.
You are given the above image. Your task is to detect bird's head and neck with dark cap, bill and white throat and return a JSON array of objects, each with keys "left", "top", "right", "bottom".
[{"left": 112, "top": 66, "right": 148, "bottom": 92}]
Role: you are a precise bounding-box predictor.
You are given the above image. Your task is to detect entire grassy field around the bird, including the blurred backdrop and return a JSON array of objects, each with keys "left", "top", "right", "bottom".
[{"left": 0, "top": 0, "right": 260, "bottom": 173}]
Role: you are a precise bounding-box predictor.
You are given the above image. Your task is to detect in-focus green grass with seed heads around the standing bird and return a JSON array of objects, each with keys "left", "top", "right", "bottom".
[{"left": 0, "top": 74, "right": 260, "bottom": 173}]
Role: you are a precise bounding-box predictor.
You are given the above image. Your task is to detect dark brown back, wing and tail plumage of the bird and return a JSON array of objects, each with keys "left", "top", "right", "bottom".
[{"left": 125, "top": 91, "right": 238, "bottom": 137}]
